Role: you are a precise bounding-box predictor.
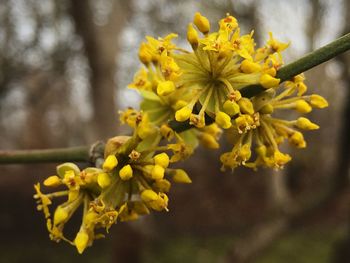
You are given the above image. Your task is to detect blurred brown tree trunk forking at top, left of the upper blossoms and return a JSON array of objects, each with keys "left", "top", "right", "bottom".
[{"left": 71, "top": 0, "right": 129, "bottom": 140}]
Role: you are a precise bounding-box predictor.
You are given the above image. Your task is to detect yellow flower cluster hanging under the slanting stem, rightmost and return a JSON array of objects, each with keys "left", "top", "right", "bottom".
[{"left": 220, "top": 75, "right": 328, "bottom": 170}]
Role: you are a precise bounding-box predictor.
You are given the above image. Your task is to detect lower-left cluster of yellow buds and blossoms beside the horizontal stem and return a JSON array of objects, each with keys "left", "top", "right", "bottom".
[{"left": 34, "top": 109, "right": 192, "bottom": 253}]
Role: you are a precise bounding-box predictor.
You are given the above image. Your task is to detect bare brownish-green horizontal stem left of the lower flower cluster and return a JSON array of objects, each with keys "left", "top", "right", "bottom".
[{"left": 0, "top": 146, "right": 90, "bottom": 164}]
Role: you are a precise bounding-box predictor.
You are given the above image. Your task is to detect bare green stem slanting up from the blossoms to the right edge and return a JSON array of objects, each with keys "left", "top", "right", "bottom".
[{"left": 240, "top": 33, "right": 350, "bottom": 98}]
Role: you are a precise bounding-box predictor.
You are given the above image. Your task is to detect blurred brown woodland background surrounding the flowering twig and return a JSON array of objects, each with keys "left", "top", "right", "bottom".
[{"left": 0, "top": 0, "right": 350, "bottom": 263}]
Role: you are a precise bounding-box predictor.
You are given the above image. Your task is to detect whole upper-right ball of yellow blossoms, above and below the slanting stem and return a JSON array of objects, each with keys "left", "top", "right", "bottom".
[{"left": 129, "top": 12, "right": 328, "bottom": 170}]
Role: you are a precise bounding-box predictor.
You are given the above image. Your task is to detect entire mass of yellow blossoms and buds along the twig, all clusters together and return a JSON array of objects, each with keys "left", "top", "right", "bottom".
[{"left": 34, "top": 13, "right": 328, "bottom": 253}]
